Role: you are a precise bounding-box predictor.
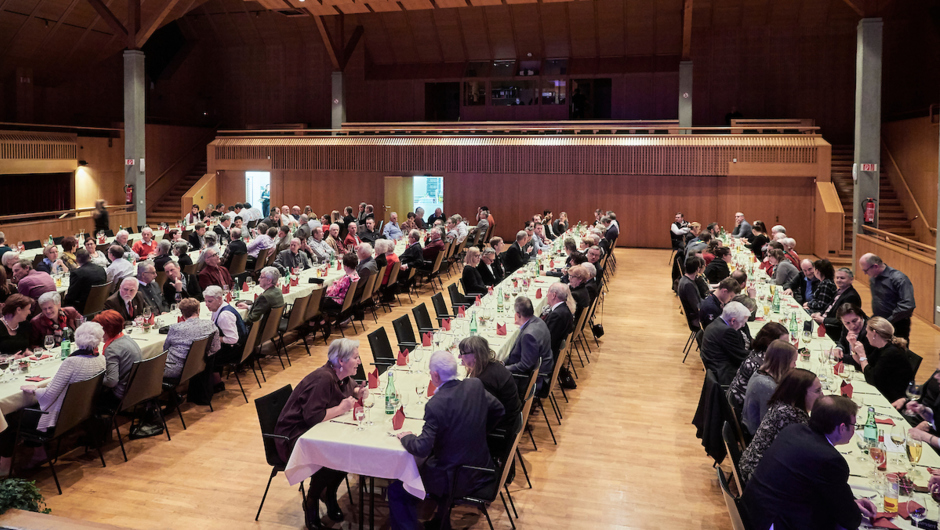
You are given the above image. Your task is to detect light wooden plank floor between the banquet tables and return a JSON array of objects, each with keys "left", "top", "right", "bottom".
[{"left": 12, "top": 249, "right": 940, "bottom": 530}]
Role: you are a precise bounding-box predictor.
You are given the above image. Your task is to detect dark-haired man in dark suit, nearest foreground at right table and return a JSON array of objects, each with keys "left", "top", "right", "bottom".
[{"left": 741, "top": 396, "right": 876, "bottom": 530}]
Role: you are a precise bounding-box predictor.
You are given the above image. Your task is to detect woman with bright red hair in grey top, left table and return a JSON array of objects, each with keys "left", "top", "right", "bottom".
[{"left": 95, "top": 309, "right": 143, "bottom": 410}]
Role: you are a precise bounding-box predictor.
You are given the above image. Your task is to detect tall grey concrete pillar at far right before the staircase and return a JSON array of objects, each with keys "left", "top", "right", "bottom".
[{"left": 852, "top": 18, "right": 882, "bottom": 268}]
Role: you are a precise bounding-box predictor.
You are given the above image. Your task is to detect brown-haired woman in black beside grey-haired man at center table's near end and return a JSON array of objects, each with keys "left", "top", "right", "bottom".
[{"left": 457, "top": 335, "right": 522, "bottom": 459}]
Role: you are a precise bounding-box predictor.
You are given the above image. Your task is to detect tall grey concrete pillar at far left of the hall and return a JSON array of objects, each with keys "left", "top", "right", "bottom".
[{"left": 124, "top": 50, "right": 147, "bottom": 226}]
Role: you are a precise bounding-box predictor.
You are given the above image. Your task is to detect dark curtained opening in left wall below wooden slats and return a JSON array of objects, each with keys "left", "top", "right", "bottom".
[{"left": 0, "top": 173, "right": 75, "bottom": 217}]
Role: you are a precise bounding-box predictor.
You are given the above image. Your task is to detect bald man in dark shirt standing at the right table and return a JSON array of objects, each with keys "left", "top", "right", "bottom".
[{"left": 858, "top": 253, "right": 917, "bottom": 342}]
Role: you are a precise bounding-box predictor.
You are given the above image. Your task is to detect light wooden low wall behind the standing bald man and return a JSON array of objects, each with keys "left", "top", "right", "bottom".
[{"left": 855, "top": 234, "right": 937, "bottom": 322}]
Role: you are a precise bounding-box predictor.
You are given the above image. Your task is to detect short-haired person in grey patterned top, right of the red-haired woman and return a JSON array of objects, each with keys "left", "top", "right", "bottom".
[{"left": 163, "top": 298, "right": 221, "bottom": 405}]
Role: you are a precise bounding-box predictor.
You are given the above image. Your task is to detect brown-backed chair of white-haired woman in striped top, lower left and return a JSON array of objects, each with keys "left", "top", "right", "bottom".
[{"left": 10, "top": 370, "right": 107, "bottom": 495}]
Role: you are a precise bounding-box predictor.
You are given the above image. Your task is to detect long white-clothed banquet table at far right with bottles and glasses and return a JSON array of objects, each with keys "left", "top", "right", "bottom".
[{"left": 732, "top": 236, "right": 940, "bottom": 529}]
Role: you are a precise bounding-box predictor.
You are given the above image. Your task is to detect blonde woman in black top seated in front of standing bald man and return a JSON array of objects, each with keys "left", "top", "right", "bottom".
[{"left": 852, "top": 317, "right": 914, "bottom": 402}]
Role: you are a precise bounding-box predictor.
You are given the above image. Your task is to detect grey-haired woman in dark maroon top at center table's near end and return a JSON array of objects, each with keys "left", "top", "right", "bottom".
[{"left": 274, "top": 339, "right": 369, "bottom": 528}]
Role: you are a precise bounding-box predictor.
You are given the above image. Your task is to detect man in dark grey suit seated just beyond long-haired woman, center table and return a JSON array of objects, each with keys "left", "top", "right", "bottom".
[{"left": 506, "top": 296, "right": 554, "bottom": 395}]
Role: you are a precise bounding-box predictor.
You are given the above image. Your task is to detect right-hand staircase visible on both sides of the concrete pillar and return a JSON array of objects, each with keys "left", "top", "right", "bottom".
[{"left": 831, "top": 145, "right": 915, "bottom": 258}]
